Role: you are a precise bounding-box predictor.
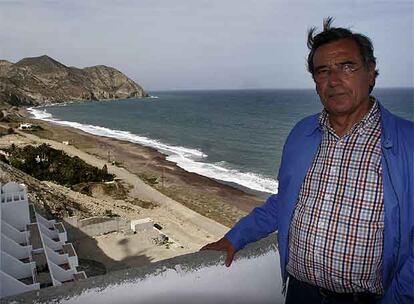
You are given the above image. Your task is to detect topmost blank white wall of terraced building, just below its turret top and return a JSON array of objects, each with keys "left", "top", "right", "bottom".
[{"left": 0, "top": 200, "right": 30, "bottom": 231}]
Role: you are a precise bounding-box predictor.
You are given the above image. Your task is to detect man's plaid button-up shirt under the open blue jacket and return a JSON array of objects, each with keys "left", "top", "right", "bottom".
[{"left": 287, "top": 101, "right": 384, "bottom": 294}]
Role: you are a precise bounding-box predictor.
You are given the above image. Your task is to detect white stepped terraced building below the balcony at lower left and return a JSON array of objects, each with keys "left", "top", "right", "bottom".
[{"left": 0, "top": 182, "right": 86, "bottom": 299}]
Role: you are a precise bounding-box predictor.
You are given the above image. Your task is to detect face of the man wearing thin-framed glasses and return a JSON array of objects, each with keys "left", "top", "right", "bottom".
[{"left": 313, "top": 39, "right": 375, "bottom": 118}]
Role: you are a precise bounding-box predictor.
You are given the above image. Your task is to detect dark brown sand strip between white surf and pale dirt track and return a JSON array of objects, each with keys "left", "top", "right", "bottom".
[{"left": 12, "top": 108, "right": 268, "bottom": 227}]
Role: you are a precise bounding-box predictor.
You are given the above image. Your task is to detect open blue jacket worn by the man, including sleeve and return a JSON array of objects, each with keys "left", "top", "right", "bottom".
[{"left": 225, "top": 105, "right": 414, "bottom": 304}]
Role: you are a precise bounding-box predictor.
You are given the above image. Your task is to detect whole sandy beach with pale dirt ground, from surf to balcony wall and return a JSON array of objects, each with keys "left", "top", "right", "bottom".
[{"left": 0, "top": 110, "right": 263, "bottom": 270}]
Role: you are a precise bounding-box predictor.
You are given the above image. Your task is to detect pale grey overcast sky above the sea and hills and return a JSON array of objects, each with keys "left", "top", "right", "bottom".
[{"left": 0, "top": 0, "right": 414, "bottom": 90}]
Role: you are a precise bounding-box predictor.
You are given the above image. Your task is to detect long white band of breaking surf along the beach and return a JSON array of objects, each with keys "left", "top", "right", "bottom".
[{"left": 28, "top": 108, "right": 278, "bottom": 193}]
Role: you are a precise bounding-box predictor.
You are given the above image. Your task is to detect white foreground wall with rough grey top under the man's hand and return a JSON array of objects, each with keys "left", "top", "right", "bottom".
[{"left": 4, "top": 236, "right": 284, "bottom": 304}]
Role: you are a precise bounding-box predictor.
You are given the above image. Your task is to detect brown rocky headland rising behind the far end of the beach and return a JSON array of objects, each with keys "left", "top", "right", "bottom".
[{"left": 0, "top": 55, "right": 148, "bottom": 105}]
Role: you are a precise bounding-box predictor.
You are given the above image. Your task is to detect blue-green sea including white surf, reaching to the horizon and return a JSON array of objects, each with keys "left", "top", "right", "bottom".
[{"left": 31, "top": 88, "right": 414, "bottom": 193}]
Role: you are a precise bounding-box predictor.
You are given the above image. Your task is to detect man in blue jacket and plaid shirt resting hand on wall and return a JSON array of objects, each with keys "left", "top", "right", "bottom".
[{"left": 202, "top": 18, "right": 414, "bottom": 303}]
